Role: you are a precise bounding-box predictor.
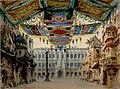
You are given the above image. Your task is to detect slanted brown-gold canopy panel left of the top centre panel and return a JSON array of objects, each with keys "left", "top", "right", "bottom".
[{"left": 7, "top": 0, "right": 41, "bottom": 23}]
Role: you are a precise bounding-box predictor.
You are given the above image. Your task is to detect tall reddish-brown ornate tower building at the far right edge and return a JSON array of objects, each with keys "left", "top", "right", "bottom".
[{"left": 102, "top": 13, "right": 120, "bottom": 87}]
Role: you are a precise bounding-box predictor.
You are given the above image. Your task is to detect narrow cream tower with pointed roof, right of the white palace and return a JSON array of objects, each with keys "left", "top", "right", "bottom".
[{"left": 87, "top": 36, "right": 102, "bottom": 83}]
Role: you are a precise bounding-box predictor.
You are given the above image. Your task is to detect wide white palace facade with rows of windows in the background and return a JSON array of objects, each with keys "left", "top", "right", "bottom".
[{"left": 34, "top": 48, "right": 87, "bottom": 78}]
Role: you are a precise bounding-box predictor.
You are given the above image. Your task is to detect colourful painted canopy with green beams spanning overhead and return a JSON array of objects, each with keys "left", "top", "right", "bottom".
[{"left": 0, "top": 0, "right": 119, "bottom": 45}]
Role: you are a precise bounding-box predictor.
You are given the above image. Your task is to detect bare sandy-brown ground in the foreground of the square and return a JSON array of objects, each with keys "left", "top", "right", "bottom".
[{"left": 5, "top": 78, "right": 117, "bottom": 89}]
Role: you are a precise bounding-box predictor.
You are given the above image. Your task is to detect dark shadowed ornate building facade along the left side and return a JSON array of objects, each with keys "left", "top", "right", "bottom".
[{"left": 0, "top": 18, "right": 35, "bottom": 88}]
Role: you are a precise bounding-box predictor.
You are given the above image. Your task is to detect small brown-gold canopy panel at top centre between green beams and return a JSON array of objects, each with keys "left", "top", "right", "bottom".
[{"left": 47, "top": 0, "right": 71, "bottom": 8}]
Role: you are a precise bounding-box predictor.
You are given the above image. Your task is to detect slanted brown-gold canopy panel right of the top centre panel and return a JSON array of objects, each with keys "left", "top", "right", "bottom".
[{"left": 76, "top": 0, "right": 110, "bottom": 20}]
